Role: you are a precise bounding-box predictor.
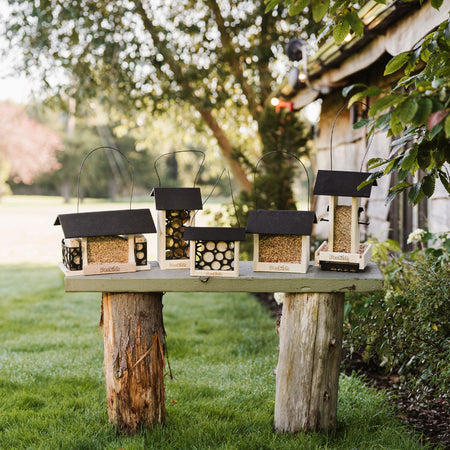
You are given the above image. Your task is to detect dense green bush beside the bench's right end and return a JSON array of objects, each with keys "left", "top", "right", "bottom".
[{"left": 344, "top": 229, "right": 450, "bottom": 401}]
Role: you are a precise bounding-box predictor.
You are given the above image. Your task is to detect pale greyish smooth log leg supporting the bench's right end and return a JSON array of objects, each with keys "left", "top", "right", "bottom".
[{"left": 275, "top": 293, "right": 344, "bottom": 433}]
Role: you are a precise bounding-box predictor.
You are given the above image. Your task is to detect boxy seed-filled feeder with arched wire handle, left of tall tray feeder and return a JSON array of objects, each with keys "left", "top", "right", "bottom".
[{"left": 247, "top": 151, "right": 317, "bottom": 273}]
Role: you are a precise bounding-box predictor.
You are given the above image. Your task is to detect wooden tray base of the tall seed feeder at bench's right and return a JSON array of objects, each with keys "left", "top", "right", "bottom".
[{"left": 314, "top": 241, "right": 372, "bottom": 271}]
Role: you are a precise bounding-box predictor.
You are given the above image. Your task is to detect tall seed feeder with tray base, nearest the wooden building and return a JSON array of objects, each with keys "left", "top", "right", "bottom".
[{"left": 313, "top": 170, "right": 376, "bottom": 271}]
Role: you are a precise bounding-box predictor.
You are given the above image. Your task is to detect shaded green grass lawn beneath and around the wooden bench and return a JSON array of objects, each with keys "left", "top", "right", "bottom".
[{"left": 0, "top": 197, "right": 428, "bottom": 450}]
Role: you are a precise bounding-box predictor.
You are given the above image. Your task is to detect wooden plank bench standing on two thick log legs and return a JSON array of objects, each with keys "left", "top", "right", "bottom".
[{"left": 65, "top": 261, "right": 383, "bottom": 433}]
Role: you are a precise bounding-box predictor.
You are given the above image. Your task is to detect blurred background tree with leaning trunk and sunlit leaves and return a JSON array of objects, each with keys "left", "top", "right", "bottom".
[{"left": 3, "top": 0, "right": 318, "bottom": 197}]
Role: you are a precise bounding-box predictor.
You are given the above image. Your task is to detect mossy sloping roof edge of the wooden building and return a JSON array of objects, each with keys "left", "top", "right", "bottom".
[{"left": 280, "top": 0, "right": 450, "bottom": 109}]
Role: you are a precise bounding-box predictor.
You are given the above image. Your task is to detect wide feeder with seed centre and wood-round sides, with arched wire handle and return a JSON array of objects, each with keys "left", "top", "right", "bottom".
[{"left": 54, "top": 147, "right": 156, "bottom": 276}]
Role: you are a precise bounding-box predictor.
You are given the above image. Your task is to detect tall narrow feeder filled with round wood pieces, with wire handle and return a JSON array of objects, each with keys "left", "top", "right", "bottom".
[{"left": 151, "top": 150, "right": 205, "bottom": 270}]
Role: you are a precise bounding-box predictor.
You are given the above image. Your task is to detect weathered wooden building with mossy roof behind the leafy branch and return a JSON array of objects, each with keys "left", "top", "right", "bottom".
[{"left": 279, "top": 0, "right": 450, "bottom": 246}]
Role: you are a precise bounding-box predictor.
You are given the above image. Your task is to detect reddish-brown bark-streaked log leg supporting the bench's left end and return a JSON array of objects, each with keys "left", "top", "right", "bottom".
[{"left": 100, "top": 292, "right": 165, "bottom": 434}]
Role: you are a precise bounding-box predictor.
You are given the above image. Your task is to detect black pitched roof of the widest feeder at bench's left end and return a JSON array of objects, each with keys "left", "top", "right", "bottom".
[{"left": 54, "top": 209, "right": 156, "bottom": 238}]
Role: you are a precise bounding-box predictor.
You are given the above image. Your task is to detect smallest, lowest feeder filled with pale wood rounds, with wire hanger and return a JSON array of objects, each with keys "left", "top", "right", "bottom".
[{"left": 184, "top": 169, "right": 245, "bottom": 277}]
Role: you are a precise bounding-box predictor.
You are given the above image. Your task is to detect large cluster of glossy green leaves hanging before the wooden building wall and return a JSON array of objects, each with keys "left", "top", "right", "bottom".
[{"left": 343, "top": 20, "right": 450, "bottom": 204}]
